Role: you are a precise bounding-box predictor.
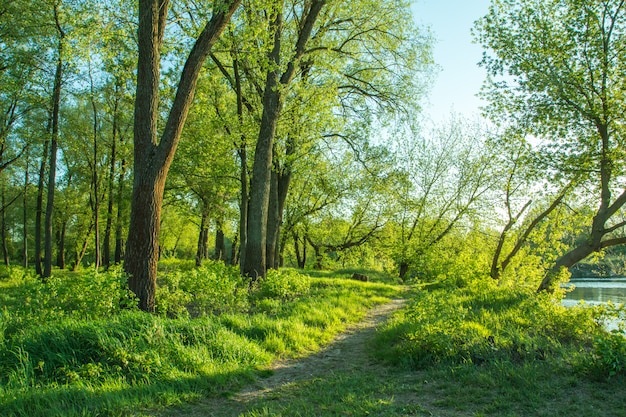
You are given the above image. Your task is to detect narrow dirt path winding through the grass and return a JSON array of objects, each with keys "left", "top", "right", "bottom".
[{"left": 162, "top": 299, "right": 406, "bottom": 417}]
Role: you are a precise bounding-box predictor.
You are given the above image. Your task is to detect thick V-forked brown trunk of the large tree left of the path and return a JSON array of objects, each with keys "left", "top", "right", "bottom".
[{"left": 124, "top": 0, "right": 241, "bottom": 311}]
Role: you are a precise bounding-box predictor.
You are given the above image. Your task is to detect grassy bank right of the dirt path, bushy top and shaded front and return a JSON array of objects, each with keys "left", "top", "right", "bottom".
[{"left": 201, "top": 281, "right": 626, "bottom": 417}]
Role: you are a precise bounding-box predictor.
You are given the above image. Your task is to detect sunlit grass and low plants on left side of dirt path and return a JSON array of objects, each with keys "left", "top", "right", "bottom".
[{"left": 0, "top": 264, "right": 399, "bottom": 416}]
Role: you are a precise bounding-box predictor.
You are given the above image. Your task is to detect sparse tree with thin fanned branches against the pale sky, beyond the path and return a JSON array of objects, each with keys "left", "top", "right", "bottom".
[{"left": 391, "top": 118, "right": 495, "bottom": 279}]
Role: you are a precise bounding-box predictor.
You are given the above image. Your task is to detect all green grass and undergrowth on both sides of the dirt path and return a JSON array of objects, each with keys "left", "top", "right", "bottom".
[{"left": 0, "top": 264, "right": 626, "bottom": 417}]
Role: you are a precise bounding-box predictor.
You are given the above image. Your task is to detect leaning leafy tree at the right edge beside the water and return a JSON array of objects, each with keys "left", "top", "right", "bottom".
[{"left": 476, "top": 0, "right": 626, "bottom": 290}]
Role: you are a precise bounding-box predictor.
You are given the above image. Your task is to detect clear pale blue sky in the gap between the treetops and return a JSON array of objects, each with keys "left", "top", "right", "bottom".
[{"left": 412, "top": 0, "right": 490, "bottom": 122}]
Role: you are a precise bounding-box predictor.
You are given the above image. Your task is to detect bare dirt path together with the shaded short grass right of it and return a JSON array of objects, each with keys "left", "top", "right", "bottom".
[{"left": 152, "top": 292, "right": 626, "bottom": 417}]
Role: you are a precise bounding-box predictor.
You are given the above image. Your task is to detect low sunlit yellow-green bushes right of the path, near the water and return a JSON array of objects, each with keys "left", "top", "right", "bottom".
[{"left": 378, "top": 280, "right": 602, "bottom": 368}]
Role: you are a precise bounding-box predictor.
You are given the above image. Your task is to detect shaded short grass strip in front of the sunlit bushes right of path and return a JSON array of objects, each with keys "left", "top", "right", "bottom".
[{"left": 200, "top": 363, "right": 626, "bottom": 417}]
